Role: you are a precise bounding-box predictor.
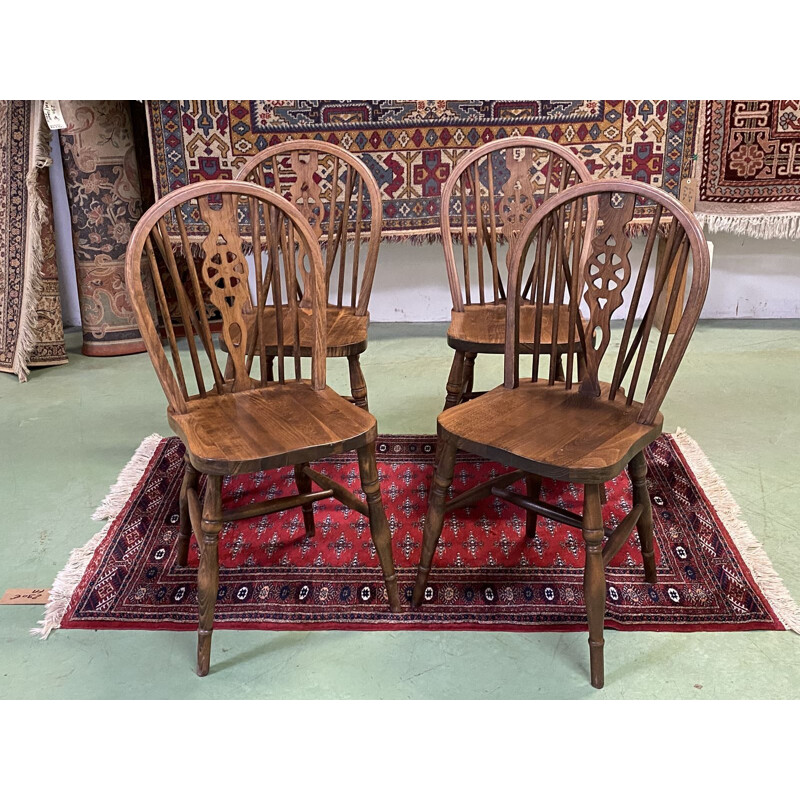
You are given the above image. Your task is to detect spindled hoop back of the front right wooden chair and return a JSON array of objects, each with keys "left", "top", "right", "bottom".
[{"left": 504, "top": 180, "right": 709, "bottom": 424}]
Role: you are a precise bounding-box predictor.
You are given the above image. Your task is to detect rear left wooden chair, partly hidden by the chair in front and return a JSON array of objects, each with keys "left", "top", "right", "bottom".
[{"left": 236, "top": 139, "right": 383, "bottom": 410}]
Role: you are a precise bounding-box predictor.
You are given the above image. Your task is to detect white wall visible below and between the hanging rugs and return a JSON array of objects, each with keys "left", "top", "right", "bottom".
[{"left": 50, "top": 123, "right": 800, "bottom": 325}]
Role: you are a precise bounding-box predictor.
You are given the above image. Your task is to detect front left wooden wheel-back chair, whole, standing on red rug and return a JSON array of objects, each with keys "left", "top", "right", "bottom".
[{"left": 126, "top": 181, "right": 400, "bottom": 675}]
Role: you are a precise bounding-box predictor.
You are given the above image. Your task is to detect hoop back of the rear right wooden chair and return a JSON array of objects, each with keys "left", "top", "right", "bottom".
[{"left": 441, "top": 136, "right": 591, "bottom": 311}]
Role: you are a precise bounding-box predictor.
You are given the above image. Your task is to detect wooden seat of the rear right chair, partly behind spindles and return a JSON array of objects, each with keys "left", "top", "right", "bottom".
[{"left": 447, "top": 302, "right": 585, "bottom": 354}]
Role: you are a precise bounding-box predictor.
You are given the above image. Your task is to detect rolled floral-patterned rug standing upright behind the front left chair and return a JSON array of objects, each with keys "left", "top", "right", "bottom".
[{"left": 60, "top": 100, "right": 150, "bottom": 356}]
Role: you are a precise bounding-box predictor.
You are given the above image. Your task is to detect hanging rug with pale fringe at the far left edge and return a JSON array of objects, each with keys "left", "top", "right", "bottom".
[{"left": 0, "top": 100, "right": 67, "bottom": 381}]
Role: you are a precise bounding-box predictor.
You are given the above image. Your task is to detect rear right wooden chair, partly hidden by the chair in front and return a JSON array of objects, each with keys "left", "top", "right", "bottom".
[{"left": 441, "top": 136, "right": 591, "bottom": 409}]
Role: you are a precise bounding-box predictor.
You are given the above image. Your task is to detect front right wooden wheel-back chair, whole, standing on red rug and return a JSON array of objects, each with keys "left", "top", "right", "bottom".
[{"left": 412, "top": 180, "right": 709, "bottom": 688}]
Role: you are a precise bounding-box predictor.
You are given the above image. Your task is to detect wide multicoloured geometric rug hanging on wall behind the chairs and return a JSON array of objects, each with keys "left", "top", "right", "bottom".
[{"left": 147, "top": 100, "right": 698, "bottom": 240}]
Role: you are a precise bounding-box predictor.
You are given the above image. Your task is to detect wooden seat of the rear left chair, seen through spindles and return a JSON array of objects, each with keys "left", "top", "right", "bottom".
[{"left": 236, "top": 306, "right": 369, "bottom": 357}]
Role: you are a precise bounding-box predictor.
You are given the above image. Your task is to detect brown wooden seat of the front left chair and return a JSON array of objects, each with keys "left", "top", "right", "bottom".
[{"left": 168, "top": 381, "right": 377, "bottom": 475}]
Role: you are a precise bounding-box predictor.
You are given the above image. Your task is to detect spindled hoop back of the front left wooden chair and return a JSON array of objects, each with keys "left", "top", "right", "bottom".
[{"left": 125, "top": 180, "right": 326, "bottom": 414}]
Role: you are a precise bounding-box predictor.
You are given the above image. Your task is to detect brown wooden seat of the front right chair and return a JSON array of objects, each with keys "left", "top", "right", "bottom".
[{"left": 437, "top": 380, "right": 664, "bottom": 483}]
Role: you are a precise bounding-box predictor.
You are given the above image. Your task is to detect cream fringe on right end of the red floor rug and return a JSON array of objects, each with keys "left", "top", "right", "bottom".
[{"left": 672, "top": 428, "right": 800, "bottom": 634}]
